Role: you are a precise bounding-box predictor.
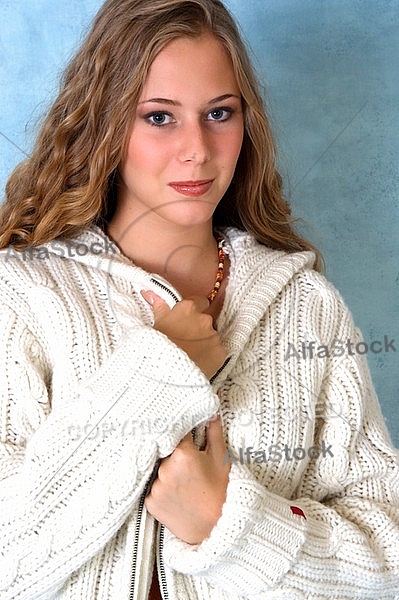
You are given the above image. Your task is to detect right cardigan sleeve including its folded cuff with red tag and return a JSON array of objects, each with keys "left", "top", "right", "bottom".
[{"left": 164, "top": 290, "right": 399, "bottom": 600}]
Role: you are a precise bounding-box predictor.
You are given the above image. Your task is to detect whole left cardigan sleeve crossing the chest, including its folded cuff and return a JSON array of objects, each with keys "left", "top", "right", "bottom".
[{"left": 0, "top": 306, "right": 218, "bottom": 600}]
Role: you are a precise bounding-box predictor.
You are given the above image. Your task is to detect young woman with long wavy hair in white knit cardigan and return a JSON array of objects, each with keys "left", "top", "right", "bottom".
[{"left": 0, "top": 0, "right": 399, "bottom": 600}]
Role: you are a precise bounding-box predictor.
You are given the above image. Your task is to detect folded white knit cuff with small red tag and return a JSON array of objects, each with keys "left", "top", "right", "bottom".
[{"left": 164, "top": 464, "right": 308, "bottom": 597}]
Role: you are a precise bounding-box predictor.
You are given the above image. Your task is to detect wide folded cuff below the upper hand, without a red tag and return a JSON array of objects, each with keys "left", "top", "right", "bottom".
[{"left": 79, "top": 327, "right": 219, "bottom": 458}]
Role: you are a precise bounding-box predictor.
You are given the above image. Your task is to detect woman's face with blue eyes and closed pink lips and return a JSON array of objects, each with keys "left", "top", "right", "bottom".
[{"left": 118, "top": 34, "right": 244, "bottom": 226}]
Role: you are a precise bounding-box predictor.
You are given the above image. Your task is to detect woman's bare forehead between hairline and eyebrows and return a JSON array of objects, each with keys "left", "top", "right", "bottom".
[{"left": 142, "top": 33, "right": 239, "bottom": 98}]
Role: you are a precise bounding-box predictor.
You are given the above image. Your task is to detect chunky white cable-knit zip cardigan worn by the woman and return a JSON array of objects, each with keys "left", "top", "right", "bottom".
[{"left": 0, "top": 227, "right": 399, "bottom": 600}]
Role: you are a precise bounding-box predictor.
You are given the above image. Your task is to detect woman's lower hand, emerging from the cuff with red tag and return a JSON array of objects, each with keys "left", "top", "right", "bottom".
[{"left": 145, "top": 417, "right": 231, "bottom": 544}]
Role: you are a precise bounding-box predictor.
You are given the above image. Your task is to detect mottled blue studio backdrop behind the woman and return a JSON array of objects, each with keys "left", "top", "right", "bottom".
[{"left": 0, "top": 0, "right": 399, "bottom": 446}]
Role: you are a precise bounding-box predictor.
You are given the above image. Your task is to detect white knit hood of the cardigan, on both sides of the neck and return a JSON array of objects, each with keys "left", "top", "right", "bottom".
[{"left": 11, "top": 225, "right": 315, "bottom": 353}]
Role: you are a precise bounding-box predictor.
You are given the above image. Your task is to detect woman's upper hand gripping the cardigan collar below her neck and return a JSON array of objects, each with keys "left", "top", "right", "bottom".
[{"left": 141, "top": 291, "right": 227, "bottom": 379}]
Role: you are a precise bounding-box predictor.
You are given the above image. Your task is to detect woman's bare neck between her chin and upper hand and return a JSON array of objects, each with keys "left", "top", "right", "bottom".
[{"left": 107, "top": 219, "right": 218, "bottom": 297}]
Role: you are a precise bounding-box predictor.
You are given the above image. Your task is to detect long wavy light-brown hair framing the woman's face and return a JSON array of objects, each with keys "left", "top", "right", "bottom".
[{"left": 0, "top": 0, "right": 322, "bottom": 269}]
